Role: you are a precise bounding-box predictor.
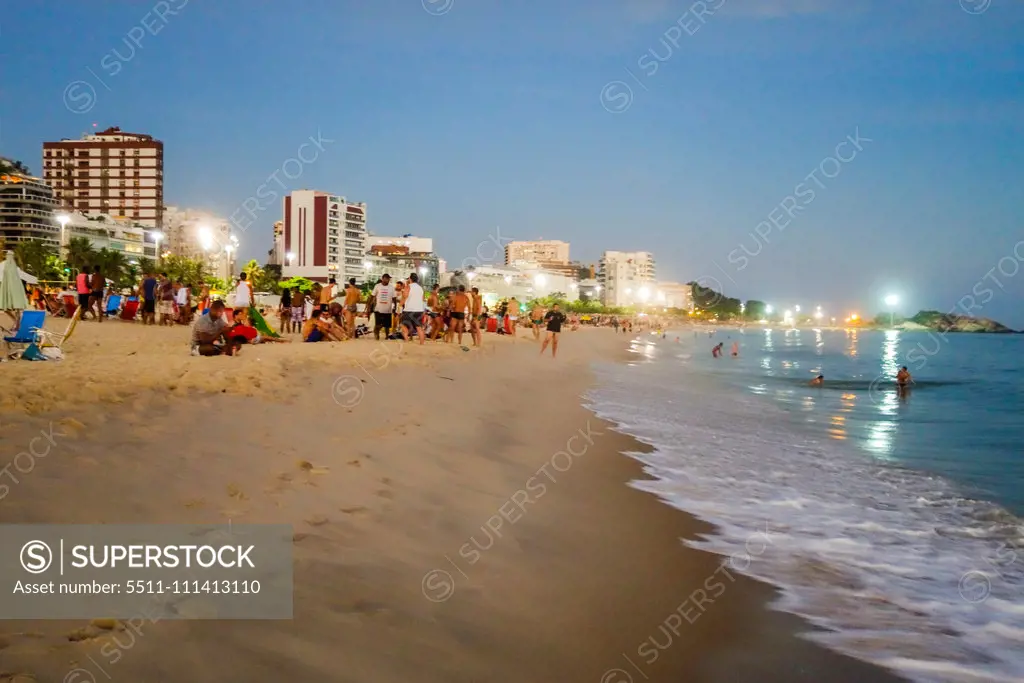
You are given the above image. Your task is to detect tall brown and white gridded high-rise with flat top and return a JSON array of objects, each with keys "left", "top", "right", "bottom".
[{"left": 43, "top": 127, "right": 164, "bottom": 228}]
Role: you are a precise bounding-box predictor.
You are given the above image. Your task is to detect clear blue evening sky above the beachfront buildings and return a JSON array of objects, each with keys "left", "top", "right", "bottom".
[{"left": 0, "top": 0, "right": 1024, "bottom": 328}]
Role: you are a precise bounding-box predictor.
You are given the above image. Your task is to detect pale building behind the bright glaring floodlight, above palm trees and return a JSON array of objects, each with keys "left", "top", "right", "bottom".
[{"left": 160, "top": 206, "right": 239, "bottom": 282}]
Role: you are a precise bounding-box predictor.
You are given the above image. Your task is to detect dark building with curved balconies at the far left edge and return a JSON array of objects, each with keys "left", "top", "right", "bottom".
[{"left": 0, "top": 173, "right": 60, "bottom": 249}]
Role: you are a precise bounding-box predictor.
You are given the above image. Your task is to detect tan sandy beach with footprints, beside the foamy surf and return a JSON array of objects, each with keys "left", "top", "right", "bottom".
[{"left": 0, "top": 322, "right": 913, "bottom": 683}]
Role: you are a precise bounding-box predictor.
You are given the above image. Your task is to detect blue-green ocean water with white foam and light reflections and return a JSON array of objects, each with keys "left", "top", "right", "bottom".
[{"left": 588, "top": 329, "right": 1024, "bottom": 683}]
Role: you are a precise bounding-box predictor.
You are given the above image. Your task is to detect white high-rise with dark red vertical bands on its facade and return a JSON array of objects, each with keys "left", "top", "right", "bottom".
[{"left": 283, "top": 189, "right": 367, "bottom": 283}]
